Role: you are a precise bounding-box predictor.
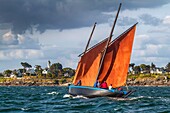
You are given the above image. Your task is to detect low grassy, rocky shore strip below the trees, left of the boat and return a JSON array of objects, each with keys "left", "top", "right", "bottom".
[{"left": 0, "top": 76, "right": 72, "bottom": 86}]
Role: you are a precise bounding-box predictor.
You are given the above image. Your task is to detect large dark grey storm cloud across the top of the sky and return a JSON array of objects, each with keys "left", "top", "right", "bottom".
[{"left": 0, "top": 0, "right": 169, "bottom": 34}]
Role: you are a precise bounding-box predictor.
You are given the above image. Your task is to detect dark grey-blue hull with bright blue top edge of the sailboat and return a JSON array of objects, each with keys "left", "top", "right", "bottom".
[{"left": 69, "top": 85, "right": 134, "bottom": 98}]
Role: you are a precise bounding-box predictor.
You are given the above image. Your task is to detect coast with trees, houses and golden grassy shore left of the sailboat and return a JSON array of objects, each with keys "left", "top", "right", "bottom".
[{"left": 0, "top": 61, "right": 75, "bottom": 85}]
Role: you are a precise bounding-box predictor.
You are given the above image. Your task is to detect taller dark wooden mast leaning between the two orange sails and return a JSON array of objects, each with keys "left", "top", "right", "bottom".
[{"left": 96, "top": 3, "right": 122, "bottom": 80}]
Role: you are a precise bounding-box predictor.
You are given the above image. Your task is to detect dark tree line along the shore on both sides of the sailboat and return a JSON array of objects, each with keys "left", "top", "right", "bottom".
[{"left": 0, "top": 61, "right": 170, "bottom": 78}]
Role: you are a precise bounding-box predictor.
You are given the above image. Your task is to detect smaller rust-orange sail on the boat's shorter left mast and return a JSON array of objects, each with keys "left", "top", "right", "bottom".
[{"left": 73, "top": 39, "right": 107, "bottom": 86}]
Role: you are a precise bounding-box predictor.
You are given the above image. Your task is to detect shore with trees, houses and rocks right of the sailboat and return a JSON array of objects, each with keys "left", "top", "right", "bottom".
[{"left": 128, "top": 63, "right": 170, "bottom": 85}]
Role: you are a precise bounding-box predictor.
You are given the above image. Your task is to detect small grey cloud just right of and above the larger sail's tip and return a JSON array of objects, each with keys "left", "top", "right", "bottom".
[{"left": 139, "top": 14, "right": 162, "bottom": 26}]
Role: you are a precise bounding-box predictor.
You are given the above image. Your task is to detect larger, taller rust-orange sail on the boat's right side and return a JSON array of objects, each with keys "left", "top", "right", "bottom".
[{"left": 98, "top": 24, "right": 136, "bottom": 88}]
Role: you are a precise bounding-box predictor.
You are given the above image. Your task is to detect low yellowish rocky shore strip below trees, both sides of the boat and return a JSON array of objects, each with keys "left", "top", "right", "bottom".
[{"left": 0, "top": 76, "right": 170, "bottom": 86}]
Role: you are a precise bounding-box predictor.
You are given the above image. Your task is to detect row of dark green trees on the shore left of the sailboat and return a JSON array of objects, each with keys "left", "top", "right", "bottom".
[{"left": 0, "top": 61, "right": 75, "bottom": 78}]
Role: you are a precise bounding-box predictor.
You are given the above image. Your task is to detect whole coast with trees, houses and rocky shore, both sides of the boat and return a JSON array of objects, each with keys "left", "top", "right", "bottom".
[{"left": 0, "top": 61, "right": 170, "bottom": 85}]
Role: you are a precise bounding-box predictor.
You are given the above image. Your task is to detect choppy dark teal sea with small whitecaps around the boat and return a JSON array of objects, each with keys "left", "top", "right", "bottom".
[{"left": 0, "top": 87, "right": 170, "bottom": 113}]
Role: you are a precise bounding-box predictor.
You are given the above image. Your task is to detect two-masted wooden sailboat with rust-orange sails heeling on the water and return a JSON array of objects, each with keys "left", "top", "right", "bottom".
[{"left": 68, "top": 3, "right": 137, "bottom": 98}]
